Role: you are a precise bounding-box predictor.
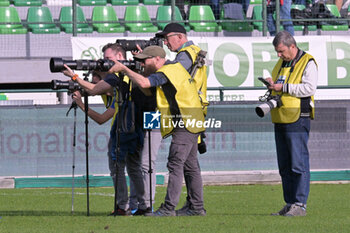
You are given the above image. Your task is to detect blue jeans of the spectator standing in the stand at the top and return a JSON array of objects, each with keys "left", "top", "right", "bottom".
[{"left": 266, "top": 0, "right": 294, "bottom": 36}]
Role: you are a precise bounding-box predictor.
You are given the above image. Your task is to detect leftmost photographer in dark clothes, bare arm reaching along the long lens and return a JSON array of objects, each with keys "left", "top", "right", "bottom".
[{"left": 63, "top": 44, "right": 160, "bottom": 215}]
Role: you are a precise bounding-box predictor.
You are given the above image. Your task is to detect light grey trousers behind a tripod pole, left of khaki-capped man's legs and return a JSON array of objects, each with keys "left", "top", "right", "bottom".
[{"left": 130, "top": 129, "right": 162, "bottom": 209}]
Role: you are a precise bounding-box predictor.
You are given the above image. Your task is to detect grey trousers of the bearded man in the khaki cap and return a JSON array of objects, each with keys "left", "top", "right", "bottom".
[{"left": 164, "top": 128, "right": 204, "bottom": 210}]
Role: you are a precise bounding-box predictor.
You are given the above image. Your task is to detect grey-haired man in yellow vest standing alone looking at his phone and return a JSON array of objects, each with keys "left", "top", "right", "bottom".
[{"left": 266, "top": 31, "right": 318, "bottom": 216}]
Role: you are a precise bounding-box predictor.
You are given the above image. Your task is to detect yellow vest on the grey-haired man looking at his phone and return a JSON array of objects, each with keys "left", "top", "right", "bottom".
[{"left": 271, "top": 53, "right": 315, "bottom": 123}]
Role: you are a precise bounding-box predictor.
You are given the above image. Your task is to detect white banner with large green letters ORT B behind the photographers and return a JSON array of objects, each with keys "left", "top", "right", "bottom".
[{"left": 72, "top": 36, "right": 350, "bottom": 90}]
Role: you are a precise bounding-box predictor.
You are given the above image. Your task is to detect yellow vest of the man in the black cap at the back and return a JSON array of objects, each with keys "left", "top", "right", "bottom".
[{"left": 179, "top": 45, "right": 209, "bottom": 115}]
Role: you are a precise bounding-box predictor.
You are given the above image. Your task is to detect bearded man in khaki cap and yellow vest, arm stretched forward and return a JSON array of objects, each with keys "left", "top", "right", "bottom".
[{"left": 109, "top": 46, "right": 206, "bottom": 216}]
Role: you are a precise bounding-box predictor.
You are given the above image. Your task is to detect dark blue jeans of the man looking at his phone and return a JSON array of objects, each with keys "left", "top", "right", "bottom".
[{"left": 275, "top": 117, "right": 310, "bottom": 205}]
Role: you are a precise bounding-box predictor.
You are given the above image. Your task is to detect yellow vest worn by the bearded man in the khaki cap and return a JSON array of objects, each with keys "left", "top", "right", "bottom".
[{"left": 157, "top": 63, "right": 205, "bottom": 137}]
